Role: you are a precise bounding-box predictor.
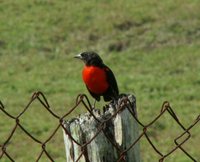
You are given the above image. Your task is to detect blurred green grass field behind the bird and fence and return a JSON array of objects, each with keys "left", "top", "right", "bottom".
[{"left": 0, "top": 0, "right": 200, "bottom": 162}]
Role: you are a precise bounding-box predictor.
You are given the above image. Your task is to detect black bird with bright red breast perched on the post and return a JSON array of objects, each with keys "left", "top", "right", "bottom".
[{"left": 74, "top": 51, "right": 119, "bottom": 102}]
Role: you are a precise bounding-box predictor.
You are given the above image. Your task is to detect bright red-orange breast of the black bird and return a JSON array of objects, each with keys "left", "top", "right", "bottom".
[{"left": 82, "top": 66, "right": 109, "bottom": 94}]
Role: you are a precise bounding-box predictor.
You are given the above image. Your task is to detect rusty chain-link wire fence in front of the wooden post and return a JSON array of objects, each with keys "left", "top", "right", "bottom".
[{"left": 0, "top": 92, "right": 200, "bottom": 162}]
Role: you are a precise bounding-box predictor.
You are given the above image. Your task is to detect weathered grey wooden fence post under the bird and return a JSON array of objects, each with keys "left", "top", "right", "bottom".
[{"left": 63, "top": 95, "right": 140, "bottom": 162}]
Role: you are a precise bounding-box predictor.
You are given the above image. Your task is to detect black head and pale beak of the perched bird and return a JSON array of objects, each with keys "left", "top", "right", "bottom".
[{"left": 75, "top": 51, "right": 103, "bottom": 66}]
